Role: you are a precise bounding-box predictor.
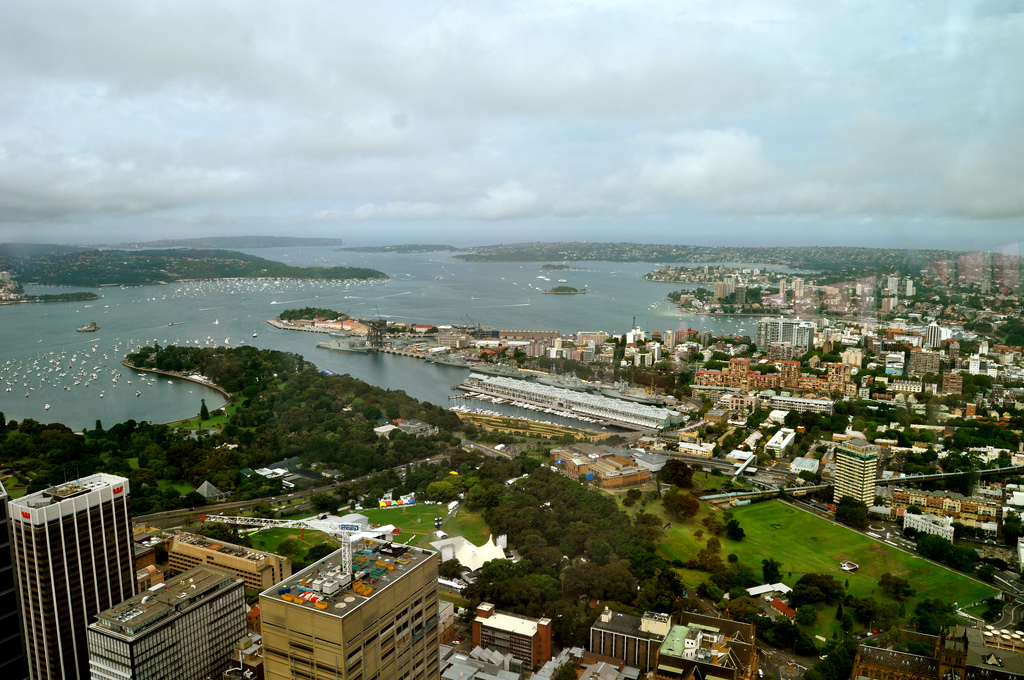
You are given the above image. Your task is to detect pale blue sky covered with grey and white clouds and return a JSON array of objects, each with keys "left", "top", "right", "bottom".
[{"left": 0, "top": 0, "right": 1024, "bottom": 250}]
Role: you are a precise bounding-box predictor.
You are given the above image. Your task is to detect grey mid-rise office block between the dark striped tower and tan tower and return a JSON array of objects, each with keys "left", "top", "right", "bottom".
[{"left": 87, "top": 566, "right": 246, "bottom": 680}]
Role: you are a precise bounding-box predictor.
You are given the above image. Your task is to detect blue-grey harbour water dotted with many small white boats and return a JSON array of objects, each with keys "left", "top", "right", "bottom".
[{"left": 0, "top": 248, "right": 790, "bottom": 429}]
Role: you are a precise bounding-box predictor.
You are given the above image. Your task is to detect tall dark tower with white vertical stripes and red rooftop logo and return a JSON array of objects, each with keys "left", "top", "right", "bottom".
[{"left": 7, "top": 473, "right": 135, "bottom": 680}]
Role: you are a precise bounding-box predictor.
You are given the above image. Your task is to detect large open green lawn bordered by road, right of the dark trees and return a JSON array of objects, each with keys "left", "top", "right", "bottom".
[{"left": 722, "top": 501, "right": 996, "bottom": 611}]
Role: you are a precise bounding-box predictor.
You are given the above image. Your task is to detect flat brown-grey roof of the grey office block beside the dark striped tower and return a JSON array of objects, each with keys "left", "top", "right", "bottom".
[{"left": 93, "top": 566, "right": 243, "bottom": 638}]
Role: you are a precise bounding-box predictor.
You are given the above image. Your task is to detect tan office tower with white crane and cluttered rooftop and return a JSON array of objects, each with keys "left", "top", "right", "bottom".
[{"left": 259, "top": 539, "right": 440, "bottom": 680}]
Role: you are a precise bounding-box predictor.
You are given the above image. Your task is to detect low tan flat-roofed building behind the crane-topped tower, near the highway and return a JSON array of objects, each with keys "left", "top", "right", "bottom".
[{"left": 167, "top": 533, "right": 292, "bottom": 590}]
